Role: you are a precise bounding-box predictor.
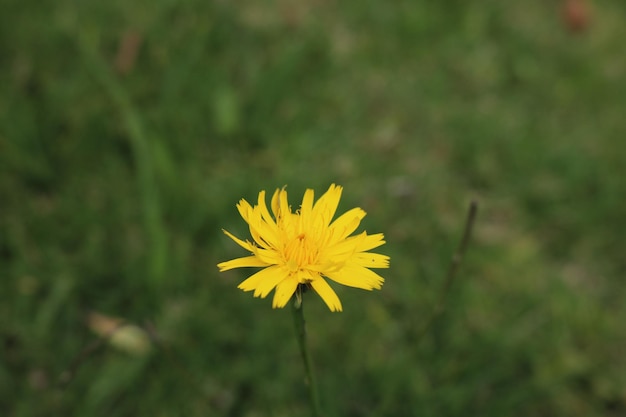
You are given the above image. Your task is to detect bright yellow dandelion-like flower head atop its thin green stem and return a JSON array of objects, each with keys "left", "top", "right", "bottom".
[{"left": 217, "top": 184, "right": 389, "bottom": 311}]
